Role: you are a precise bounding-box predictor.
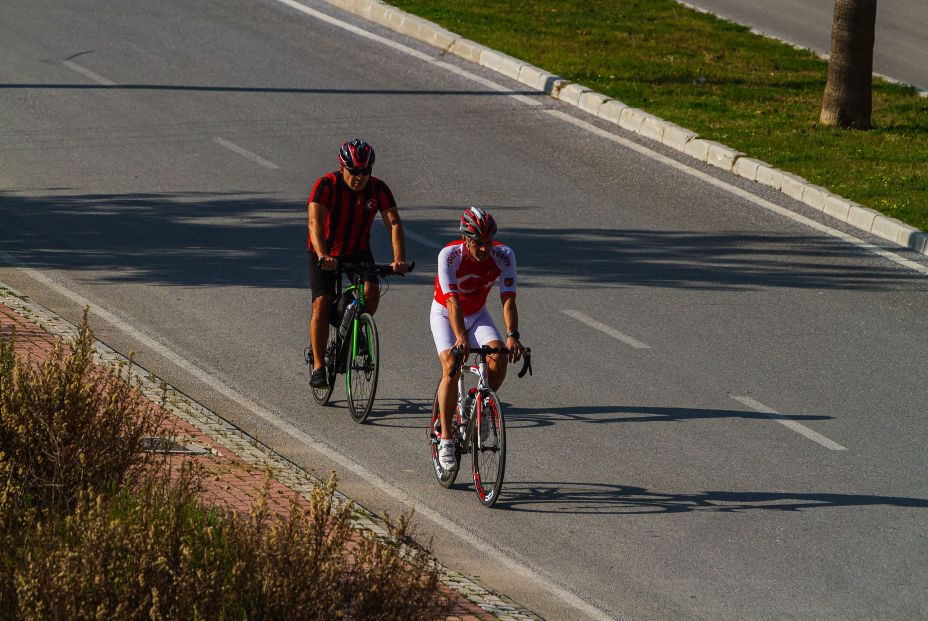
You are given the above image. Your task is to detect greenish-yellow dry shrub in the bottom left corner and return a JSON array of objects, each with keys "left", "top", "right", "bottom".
[{"left": 15, "top": 463, "right": 255, "bottom": 621}]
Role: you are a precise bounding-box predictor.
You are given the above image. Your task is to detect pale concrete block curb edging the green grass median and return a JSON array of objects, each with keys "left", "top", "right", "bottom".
[{"left": 325, "top": 0, "right": 928, "bottom": 255}]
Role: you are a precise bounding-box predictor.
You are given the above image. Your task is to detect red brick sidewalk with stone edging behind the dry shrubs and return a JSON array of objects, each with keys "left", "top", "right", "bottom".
[{"left": 0, "top": 294, "right": 538, "bottom": 621}]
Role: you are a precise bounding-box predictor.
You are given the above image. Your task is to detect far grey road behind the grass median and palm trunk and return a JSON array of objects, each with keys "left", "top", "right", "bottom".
[{"left": 686, "top": 0, "right": 928, "bottom": 90}]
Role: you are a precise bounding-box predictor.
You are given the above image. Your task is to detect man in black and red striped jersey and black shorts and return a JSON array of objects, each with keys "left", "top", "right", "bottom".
[{"left": 309, "top": 138, "right": 409, "bottom": 388}]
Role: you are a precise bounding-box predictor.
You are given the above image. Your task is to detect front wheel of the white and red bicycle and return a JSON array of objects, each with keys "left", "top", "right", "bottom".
[{"left": 471, "top": 390, "right": 506, "bottom": 507}]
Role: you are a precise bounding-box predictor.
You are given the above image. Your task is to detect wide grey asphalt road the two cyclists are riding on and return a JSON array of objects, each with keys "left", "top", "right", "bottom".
[{"left": 0, "top": 0, "right": 928, "bottom": 620}]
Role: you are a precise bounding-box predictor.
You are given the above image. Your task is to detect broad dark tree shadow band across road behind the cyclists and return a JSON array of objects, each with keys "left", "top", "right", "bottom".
[{"left": 0, "top": 188, "right": 928, "bottom": 292}]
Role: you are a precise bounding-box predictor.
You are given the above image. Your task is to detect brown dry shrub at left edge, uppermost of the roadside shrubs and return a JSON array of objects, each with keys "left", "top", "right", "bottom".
[{"left": 0, "top": 310, "right": 161, "bottom": 511}]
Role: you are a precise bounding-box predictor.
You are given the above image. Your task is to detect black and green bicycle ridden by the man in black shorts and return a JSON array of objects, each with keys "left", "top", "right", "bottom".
[{"left": 305, "top": 262, "right": 416, "bottom": 424}]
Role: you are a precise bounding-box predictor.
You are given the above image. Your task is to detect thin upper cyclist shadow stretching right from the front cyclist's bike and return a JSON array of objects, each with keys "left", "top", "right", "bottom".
[{"left": 503, "top": 402, "right": 832, "bottom": 429}]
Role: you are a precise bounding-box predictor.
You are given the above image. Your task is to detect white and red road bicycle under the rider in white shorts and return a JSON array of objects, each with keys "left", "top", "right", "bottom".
[{"left": 428, "top": 346, "right": 532, "bottom": 507}]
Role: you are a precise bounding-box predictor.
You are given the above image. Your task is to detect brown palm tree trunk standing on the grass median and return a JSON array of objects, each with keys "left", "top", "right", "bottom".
[{"left": 819, "top": 0, "right": 877, "bottom": 129}]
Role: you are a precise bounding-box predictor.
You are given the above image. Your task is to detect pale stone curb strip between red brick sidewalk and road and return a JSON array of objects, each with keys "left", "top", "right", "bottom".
[{"left": 0, "top": 282, "right": 540, "bottom": 621}]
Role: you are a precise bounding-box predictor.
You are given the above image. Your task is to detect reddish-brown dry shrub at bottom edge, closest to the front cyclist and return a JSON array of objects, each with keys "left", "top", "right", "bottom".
[{"left": 249, "top": 473, "right": 452, "bottom": 621}]
